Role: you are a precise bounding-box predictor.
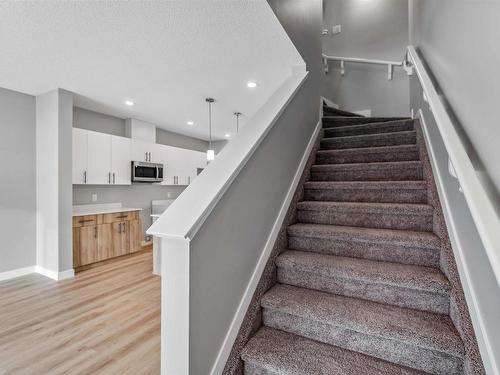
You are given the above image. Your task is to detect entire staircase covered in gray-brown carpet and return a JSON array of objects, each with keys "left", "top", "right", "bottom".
[{"left": 241, "top": 108, "right": 464, "bottom": 375}]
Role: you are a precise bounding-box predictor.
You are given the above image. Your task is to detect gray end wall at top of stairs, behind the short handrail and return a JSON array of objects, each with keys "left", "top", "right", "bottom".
[{"left": 323, "top": 0, "right": 409, "bottom": 116}]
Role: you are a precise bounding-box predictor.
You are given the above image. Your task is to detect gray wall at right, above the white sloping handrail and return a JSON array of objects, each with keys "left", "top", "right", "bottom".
[{"left": 410, "top": 0, "right": 500, "bottom": 194}]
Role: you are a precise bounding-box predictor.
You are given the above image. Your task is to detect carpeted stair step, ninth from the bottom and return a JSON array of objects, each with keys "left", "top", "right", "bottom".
[{"left": 320, "top": 130, "right": 417, "bottom": 150}]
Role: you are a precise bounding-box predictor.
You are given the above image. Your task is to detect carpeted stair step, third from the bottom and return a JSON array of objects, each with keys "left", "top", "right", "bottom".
[{"left": 276, "top": 250, "right": 450, "bottom": 314}]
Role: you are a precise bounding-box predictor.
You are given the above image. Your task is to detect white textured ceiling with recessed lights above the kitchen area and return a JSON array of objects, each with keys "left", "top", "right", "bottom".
[{"left": 0, "top": 0, "right": 304, "bottom": 139}]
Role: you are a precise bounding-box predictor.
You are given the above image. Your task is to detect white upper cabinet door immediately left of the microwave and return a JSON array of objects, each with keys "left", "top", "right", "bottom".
[{"left": 111, "top": 135, "right": 132, "bottom": 185}]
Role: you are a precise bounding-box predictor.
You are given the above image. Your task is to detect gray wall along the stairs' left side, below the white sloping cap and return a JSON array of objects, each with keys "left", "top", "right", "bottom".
[{"left": 190, "top": 0, "right": 322, "bottom": 375}]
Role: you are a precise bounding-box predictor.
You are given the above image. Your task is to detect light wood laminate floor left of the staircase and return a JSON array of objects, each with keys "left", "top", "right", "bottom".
[{"left": 0, "top": 251, "right": 160, "bottom": 375}]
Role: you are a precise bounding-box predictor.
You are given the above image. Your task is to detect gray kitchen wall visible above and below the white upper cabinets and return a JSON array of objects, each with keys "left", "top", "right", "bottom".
[{"left": 73, "top": 107, "right": 209, "bottom": 239}]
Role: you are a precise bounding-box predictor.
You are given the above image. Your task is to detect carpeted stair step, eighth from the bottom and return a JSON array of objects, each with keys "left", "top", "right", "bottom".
[{"left": 316, "top": 145, "right": 420, "bottom": 164}]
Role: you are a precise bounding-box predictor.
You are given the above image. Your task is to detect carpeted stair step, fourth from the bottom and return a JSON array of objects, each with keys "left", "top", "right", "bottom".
[{"left": 287, "top": 224, "right": 440, "bottom": 268}]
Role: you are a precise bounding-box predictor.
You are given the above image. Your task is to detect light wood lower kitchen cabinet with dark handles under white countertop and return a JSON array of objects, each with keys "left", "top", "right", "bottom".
[{"left": 73, "top": 211, "right": 143, "bottom": 268}]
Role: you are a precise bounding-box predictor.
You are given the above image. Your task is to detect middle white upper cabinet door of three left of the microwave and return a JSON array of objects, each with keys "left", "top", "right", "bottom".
[{"left": 87, "top": 131, "right": 112, "bottom": 185}]
